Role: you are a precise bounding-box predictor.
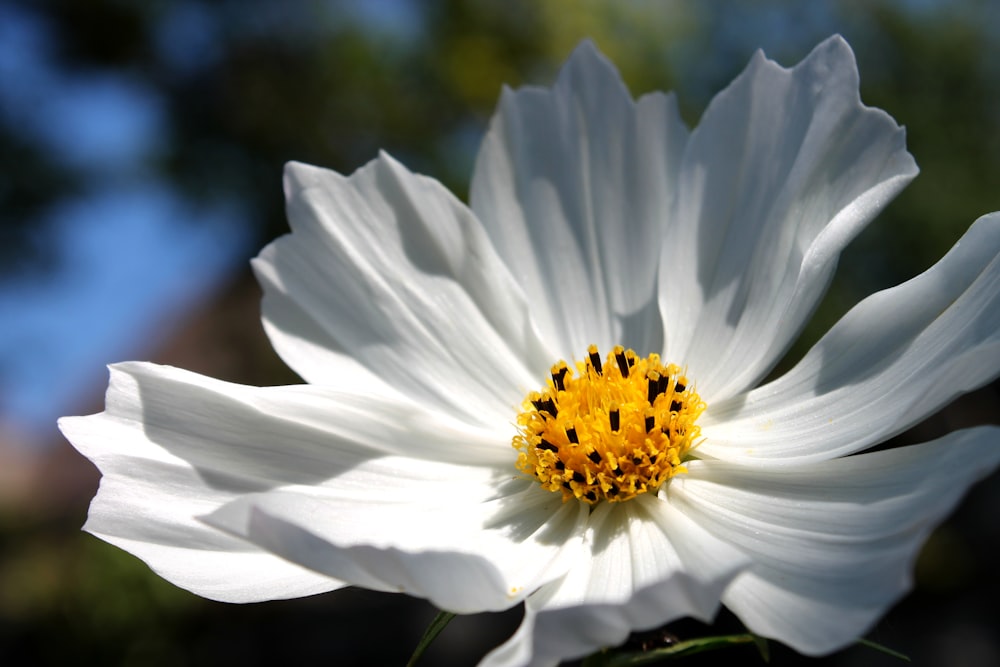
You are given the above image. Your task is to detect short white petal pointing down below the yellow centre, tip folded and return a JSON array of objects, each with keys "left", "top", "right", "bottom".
[{"left": 482, "top": 496, "right": 749, "bottom": 667}]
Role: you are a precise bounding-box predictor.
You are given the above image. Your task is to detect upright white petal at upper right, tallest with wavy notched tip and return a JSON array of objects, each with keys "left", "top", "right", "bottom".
[{"left": 660, "top": 37, "right": 917, "bottom": 402}]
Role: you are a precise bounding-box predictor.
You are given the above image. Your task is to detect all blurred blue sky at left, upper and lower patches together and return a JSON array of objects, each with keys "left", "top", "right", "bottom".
[{"left": 0, "top": 7, "right": 249, "bottom": 439}]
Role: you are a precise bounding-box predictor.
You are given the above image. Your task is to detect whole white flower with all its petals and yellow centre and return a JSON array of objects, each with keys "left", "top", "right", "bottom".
[{"left": 60, "top": 38, "right": 1000, "bottom": 665}]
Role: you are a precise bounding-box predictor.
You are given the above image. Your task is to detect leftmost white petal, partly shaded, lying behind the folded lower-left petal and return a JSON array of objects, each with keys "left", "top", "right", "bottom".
[{"left": 59, "top": 363, "right": 512, "bottom": 602}]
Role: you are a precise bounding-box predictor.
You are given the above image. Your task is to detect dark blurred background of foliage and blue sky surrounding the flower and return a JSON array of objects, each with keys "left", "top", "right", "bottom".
[{"left": 0, "top": 0, "right": 1000, "bottom": 665}]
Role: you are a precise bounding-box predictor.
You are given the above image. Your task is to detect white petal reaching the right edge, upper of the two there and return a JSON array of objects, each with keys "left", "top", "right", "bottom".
[{"left": 698, "top": 213, "right": 1000, "bottom": 463}]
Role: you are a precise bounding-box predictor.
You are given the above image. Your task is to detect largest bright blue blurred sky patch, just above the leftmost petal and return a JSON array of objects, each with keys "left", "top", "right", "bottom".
[{"left": 0, "top": 184, "right": 250, "bottom": 433}]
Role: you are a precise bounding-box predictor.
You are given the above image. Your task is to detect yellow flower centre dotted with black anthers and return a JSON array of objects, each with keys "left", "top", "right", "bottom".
[{"left": 513, "top": 345, "right": 705, "bottom": 504}]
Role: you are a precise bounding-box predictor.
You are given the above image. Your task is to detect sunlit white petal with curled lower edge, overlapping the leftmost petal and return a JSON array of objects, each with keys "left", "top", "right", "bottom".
[{"left": 205, "top": 480, "right": 587, "bottom": 613}]
